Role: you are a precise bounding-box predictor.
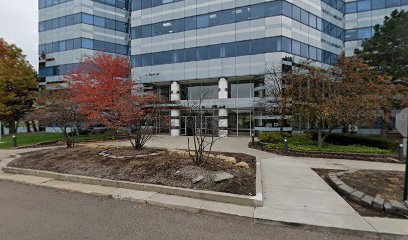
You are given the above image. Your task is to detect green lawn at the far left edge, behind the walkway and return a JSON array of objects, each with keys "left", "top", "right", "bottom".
[{"left": 0, "top": 133, "right": 62, "bottom": 149}]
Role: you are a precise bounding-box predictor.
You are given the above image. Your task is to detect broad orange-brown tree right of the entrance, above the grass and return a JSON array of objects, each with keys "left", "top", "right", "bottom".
[{"left": 286, "top": 55, "right": 381, "bottom": 147}]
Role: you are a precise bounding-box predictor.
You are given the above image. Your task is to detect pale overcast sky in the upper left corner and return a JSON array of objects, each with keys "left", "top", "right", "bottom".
[{"left": 0, "top": 0, "right": 38, "bottom": 69}]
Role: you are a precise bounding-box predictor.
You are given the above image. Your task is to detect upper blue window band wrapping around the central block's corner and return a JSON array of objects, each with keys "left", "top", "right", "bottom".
[{"left": 132, "top": 1, "right": 344, "bottom": 40}]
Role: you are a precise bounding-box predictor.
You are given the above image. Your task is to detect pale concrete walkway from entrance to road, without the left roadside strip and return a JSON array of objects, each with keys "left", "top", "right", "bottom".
[{"left": 110, "top": 136, "right": 408, "bottom": 234}]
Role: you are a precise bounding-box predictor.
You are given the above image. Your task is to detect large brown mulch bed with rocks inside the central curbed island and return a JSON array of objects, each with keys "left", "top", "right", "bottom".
[{"left": 8, "top": 146, "right": 256, "bottom": 196}]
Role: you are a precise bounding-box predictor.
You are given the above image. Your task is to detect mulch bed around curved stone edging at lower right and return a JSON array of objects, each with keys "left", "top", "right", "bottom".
[{"left": 314, "top": 169, "right": 404, "bottom": 218}]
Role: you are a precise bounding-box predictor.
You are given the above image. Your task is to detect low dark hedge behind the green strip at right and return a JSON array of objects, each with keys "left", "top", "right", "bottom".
[{"left": 310, "top": 132, "right": 398, "bottom": 150}]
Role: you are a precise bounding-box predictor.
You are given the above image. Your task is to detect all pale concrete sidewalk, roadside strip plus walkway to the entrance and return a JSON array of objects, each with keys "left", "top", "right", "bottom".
[{"left": 0, "top": 136, "right": 408, "bottom": 235}]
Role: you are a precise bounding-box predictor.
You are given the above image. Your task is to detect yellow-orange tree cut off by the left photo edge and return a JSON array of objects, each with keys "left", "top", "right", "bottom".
[{"left": 0, "top": 38, "right": 38, "bottom": 133}]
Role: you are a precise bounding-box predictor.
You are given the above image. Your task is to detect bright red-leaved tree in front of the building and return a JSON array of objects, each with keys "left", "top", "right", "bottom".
[{"left": 65, "top": 54, "right": 163, "bottom": 150}]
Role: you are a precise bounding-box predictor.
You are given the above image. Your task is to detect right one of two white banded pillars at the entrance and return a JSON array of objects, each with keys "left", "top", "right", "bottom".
[{"left": 218, "top": 78, "right": 228, "bottom": 138}]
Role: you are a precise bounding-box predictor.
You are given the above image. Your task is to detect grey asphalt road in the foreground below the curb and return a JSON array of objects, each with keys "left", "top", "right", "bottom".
[{"left": 0, "top": 181, "right": 380, "bottom": 240}]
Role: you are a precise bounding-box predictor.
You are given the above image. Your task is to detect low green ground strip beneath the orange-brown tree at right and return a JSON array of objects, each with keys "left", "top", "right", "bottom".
[{"left": 267, "top": 138, "right": 393, "bottom": 154}]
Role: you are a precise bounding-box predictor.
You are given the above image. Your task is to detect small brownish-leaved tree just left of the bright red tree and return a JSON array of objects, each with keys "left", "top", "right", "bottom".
[{"left": 27, "top": 89, "right": 86, "bottom": 148}]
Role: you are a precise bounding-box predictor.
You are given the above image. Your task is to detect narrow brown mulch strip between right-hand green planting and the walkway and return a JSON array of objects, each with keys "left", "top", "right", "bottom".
[{"left": 248, "top": 142, "right": 402, "bottom": 163}]
